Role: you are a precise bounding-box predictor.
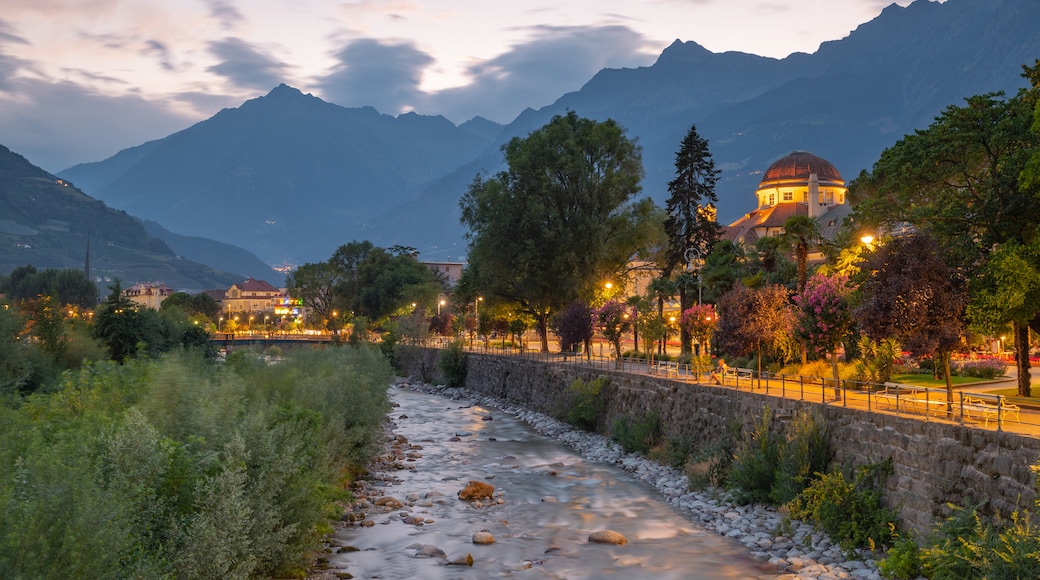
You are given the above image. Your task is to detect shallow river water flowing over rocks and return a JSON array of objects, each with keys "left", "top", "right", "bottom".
[{"left": 329, "top": 389, "right": 776, "bottom": 580}]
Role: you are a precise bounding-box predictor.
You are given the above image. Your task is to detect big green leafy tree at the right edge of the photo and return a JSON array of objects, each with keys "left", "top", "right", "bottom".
[{"left": 853, "top": 89, "right": 1040, "bottom": 399}]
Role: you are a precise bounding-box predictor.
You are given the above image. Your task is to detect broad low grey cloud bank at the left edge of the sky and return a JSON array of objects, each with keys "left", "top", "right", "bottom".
[{"left": 0, "top": 79, "right": 193, "bottom": 173}]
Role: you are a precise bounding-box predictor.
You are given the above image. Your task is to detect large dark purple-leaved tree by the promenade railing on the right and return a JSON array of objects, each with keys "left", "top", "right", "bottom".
[{"left": 856, "top": 234, "right": 968, "bottom": 404}]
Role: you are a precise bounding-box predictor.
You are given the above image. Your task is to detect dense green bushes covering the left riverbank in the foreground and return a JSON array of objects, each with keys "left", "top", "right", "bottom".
[{"left": 0, "top": 347, "right": 391, "bottom": 578}]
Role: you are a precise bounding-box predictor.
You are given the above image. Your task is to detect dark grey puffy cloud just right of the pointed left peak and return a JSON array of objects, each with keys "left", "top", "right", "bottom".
[{"left": 318, "top": 38, "right": 434, "bottom": 113}]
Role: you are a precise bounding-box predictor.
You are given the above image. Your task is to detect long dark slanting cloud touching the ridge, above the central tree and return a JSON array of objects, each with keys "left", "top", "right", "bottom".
[{"left": 423, "top": 26, "right": 661, "bottom": 123}]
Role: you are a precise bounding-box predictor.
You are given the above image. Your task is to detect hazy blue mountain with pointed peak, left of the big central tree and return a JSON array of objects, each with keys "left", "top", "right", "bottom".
[{"left": 59, "top": 84, "right": 500, "bottom": 263}]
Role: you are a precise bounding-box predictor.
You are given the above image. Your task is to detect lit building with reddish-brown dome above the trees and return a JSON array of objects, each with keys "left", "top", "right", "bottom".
[{"left": 723, "top": 151, "right": 852, "bottom": 245}]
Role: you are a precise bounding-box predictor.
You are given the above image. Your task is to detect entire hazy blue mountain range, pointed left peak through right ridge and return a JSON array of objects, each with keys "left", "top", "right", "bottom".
[{"left": 59, "top": 0, "right": 1040, "bottom": 263}]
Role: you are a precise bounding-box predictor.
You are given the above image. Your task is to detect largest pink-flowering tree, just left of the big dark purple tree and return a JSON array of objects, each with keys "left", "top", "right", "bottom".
[{"left": 795, "top": 274, "right": 853, "bottom": 393}]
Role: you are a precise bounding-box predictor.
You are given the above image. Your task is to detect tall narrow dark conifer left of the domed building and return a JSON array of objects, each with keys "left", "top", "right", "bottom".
[{"left": 662, "top": 125, "right": 722, "bottom": 353}]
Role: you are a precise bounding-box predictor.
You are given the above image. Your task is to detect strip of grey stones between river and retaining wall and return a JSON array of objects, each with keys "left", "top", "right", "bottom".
[{"left": 409, "top": 384, "right": 881, "bottom": 580}]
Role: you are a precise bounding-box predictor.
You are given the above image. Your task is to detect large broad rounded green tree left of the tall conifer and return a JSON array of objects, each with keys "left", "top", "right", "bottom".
[{"left": 460, "top": 111, "right": 648, "bottom": 350}]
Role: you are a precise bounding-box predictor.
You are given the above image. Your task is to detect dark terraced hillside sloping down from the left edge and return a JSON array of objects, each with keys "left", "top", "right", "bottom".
[{"left": 0, "top": 146, "right": 255, "bottom": 291}]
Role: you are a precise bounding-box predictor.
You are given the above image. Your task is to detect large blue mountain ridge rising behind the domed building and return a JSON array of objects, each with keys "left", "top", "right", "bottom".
[{"left": 372, "top": 0, "right": 1040, "bottom": 254}]
